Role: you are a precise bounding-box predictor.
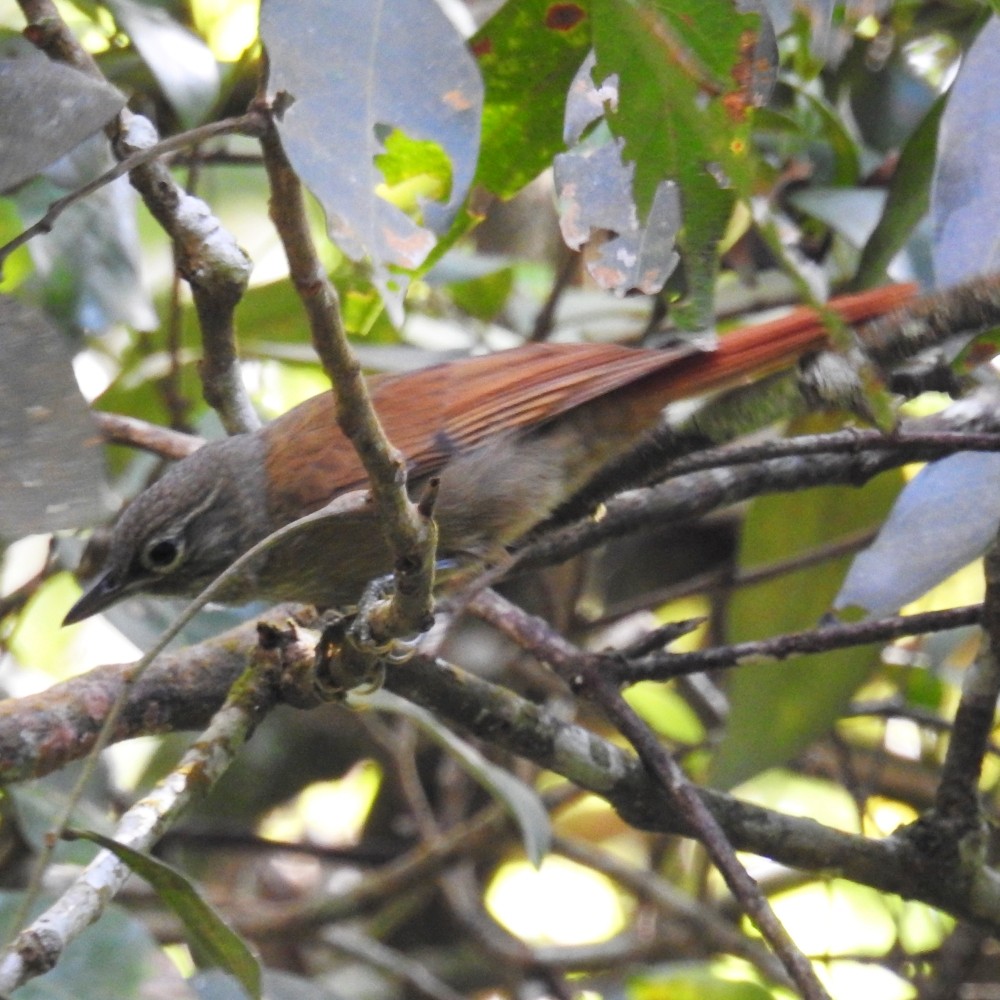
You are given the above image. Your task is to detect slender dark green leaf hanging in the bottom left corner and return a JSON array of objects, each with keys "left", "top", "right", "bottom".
[{"left": 66, "top": 830, "right": 261, "bottom": 998}]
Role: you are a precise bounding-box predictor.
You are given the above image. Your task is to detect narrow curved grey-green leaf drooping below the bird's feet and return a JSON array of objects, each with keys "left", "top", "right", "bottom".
[{"left": 358, "top": 691, "right": 552, "bottom": 866}]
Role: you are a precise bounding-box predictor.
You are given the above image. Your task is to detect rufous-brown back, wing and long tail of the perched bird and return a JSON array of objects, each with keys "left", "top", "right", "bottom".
[{"left": 263, "top": 285, "right": 914, "bottom": 519}]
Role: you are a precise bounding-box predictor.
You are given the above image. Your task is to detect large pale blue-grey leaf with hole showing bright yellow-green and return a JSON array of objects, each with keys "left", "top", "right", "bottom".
[{"left": 261, "top": 0, "right": 483, "bottom": 321}]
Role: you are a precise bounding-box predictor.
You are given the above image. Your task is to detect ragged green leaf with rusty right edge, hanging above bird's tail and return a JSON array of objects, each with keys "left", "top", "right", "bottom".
[{"left": 594, "top": 0, "right": 758, "bottom": 327}]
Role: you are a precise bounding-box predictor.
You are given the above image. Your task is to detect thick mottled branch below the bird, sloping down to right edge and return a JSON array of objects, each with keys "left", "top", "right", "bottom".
[{"left": 0, "top": 609, "right": 1000, "bottom": 933}]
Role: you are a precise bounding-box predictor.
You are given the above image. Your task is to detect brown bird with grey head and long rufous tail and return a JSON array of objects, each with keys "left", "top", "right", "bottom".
[{"left": 64, "top": 285, "right": 913, "bottom": 624}]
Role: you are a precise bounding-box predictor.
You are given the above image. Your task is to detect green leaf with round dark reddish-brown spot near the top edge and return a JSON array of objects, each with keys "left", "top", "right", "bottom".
[{"left": 469, "top": 0, "right": 590, "bottom": 198}]
